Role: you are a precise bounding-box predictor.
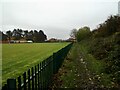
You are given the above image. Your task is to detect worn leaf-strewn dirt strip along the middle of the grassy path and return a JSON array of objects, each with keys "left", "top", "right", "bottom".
[{"left": 76, "top": 54, "right": 100, "bottom": 89}]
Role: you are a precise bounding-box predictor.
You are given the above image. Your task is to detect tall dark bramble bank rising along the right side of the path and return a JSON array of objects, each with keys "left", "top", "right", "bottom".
[{"left": 90, "top": 16, "right": 120, "bottom": 84}]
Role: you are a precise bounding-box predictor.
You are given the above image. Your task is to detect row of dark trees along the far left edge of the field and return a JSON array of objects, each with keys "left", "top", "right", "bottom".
[{"left": 0, "top": 29, "right": 47, "bottom": 42}]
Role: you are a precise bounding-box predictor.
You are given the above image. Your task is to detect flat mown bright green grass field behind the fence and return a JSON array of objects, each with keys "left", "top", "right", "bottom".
[{"left": 2, "top": 43, "right": 68, "bottom": 84}]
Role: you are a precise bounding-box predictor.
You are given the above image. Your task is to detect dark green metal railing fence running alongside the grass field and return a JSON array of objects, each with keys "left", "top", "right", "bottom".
[{"left": 2, "top": 43, "right": 72, "bottom": 90}]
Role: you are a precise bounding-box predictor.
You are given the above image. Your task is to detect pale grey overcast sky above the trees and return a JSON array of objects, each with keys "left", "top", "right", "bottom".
[{"left": 0, "top": 0, "right": 119, "bottom": 39}]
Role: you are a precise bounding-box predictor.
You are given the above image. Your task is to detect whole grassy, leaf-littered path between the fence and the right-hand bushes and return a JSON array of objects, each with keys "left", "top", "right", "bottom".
[{"left": 50, "top": 45, "right": 114, "bottom": 90}]
